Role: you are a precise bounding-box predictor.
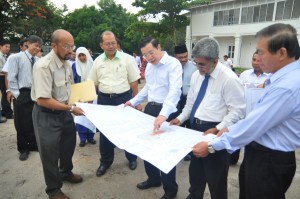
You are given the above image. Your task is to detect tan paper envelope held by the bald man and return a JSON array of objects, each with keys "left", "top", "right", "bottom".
[{"left": 69, "top": 81, "right": 97, "bottom": 104}]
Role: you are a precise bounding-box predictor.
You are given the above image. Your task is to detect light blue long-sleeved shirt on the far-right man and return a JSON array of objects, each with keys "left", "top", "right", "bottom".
[{"left": 211, "top": 61, "right": 300, "bottom": 152}]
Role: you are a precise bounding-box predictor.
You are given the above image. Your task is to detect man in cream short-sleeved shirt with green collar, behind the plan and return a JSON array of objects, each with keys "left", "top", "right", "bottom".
[{"left": 89, "top": 31, "right": 141, "bottom": 176}]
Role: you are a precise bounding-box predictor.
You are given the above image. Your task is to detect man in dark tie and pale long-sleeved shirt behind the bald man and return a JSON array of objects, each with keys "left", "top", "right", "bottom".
[{"left": 7, "top": 35, "right": 42, "bottom": 161}]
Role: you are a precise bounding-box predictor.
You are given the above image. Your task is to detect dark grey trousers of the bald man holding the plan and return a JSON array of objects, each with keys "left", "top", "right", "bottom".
[{"left": 32, "top": 104, "right": 76, "bottom": 196}]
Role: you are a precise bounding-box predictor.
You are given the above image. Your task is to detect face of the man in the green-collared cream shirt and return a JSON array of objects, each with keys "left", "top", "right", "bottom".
[{"left": 100, "top": 34, "right": 117, "bottom": 57}]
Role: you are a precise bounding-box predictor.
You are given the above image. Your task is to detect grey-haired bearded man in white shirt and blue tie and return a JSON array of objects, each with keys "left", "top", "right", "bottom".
[{"left": 170, "top": 38, "right": 246, "bottom": 199}]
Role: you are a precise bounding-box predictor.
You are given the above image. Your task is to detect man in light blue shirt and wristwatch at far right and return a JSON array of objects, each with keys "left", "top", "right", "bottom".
[{"left": 193, "top": 23, "right": 300, "bottom": 199}]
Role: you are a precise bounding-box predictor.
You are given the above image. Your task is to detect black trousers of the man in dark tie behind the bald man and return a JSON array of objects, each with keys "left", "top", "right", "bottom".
[{"left": 13, "top": 90, "right": 37, "bottom": 153}]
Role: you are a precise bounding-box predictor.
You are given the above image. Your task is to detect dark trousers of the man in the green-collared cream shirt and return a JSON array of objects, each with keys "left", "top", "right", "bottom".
[{"left": 97, "top": 92, "right": 137, "bottom": 166}]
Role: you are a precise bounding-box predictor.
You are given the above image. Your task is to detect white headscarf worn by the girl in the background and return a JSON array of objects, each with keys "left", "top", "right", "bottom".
[{"left": 75, "top": 47, "right": 94, "bottom": 82}]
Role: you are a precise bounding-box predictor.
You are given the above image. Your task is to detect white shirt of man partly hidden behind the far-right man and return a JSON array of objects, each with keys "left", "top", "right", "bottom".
[{"left": 240, "top": 69, "right": 268, "bottom": 87}]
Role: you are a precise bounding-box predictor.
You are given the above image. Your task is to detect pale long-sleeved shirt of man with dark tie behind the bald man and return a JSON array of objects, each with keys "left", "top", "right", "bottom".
[{"left": 7, "top": 50, "right": 39, "bottom": 98}]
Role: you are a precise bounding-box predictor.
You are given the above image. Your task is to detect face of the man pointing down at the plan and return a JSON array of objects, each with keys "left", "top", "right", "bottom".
[{"left": 141, "top": 43, "right": 162, "bottom": 65}]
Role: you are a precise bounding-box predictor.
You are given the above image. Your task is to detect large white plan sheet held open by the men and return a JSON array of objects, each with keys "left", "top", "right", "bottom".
[{"left": 76, "top": 103, "right": 215, "bottom": 173}]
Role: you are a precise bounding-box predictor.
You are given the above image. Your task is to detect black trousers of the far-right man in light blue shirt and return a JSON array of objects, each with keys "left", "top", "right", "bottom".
[{"left": 239, "top": 142, "right": 296, "bottom": 199}]
